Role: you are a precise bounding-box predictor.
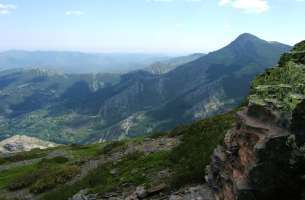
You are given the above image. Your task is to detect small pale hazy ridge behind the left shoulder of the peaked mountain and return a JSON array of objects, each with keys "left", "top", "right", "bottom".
[{"left": 145, "top": 53, "right": 205, "bottom": 74}]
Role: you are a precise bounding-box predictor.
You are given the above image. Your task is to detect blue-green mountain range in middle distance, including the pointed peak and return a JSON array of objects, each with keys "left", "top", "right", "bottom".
[{"left": 0, "top": 34, "right": 291, "bottom": 143}]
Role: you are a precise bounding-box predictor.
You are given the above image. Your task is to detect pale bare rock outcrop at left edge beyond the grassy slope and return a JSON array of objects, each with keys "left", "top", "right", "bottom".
[{"left": 0, "top": 135, "right": 57, "bottom": 153}]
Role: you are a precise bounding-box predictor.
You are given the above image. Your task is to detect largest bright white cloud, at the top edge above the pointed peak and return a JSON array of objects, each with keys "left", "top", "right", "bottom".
[{"left": 218, "top": 0, "right": 269, "bottom": 14}]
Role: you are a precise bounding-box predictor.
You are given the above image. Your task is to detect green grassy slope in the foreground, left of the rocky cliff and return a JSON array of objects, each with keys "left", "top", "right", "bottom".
[{"left": 0, "top": 112, "right": 234, "bottom": 200}]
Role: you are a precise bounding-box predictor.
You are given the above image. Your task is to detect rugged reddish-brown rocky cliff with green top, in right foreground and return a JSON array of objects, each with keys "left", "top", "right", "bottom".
[{"left": 206, "top": 41, "right": 305, "bottom": 200}]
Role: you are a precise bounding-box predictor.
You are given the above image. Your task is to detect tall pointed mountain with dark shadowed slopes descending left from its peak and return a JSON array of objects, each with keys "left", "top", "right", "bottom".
[{"left": 83, "top": 34, "right": 290, "bottom": 141}]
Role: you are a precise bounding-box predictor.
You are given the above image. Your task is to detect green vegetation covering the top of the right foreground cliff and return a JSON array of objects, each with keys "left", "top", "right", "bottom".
[{"left": 249, "top": 41, "right": 305, "bottom": 112}]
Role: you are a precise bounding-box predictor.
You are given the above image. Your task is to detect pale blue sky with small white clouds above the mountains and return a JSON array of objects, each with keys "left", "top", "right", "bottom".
[{"left": 0, "top": 0, "right": 305, "bottom": 54}]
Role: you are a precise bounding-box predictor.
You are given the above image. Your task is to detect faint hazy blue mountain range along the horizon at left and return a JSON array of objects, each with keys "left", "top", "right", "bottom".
[{"left": 0, "top": 50, "right": 170, "bottom": 73}]
